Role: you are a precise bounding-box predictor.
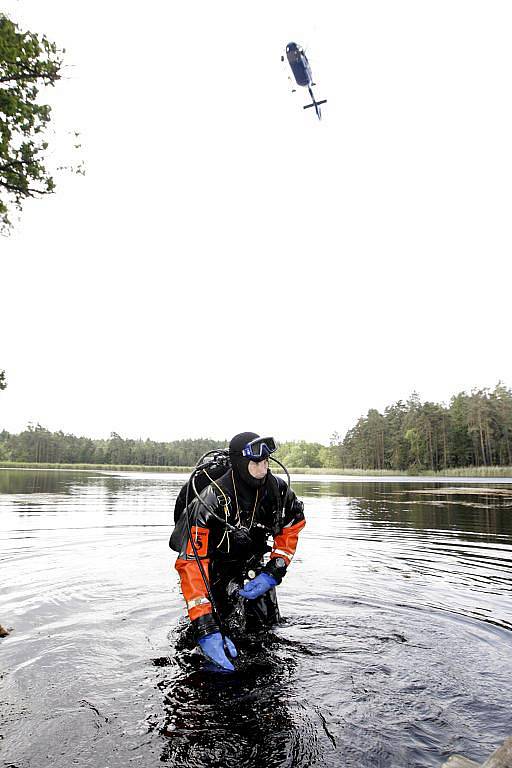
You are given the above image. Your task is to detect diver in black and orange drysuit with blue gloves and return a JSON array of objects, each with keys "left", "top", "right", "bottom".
[{"left": 169, "top": 432, "right": 306, "bottom": 672}]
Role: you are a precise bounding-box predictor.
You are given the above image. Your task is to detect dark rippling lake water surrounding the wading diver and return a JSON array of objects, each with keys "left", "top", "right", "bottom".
[{"left": 0, "top": 470, "right": 512, "bottom": 768}]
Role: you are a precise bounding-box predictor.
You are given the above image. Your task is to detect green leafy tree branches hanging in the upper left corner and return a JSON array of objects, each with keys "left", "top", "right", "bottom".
[{"left": 0, "top": 14, "right": 64, "bottom": 232}]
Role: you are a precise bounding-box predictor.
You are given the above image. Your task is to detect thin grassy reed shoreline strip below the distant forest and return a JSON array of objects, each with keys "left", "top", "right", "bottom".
[{"left": 0, "top": 461, "right": 512, "bottom": 482}]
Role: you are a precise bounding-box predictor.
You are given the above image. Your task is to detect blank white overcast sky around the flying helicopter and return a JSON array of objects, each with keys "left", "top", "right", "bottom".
[{"left": 0, "top": 0, "right": 512, "bottom": 442}]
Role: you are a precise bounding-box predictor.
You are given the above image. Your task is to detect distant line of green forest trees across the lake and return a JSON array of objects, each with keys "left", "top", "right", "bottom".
[{"left": 0, "top": 383, "right": 512, "bottom": 471}]
